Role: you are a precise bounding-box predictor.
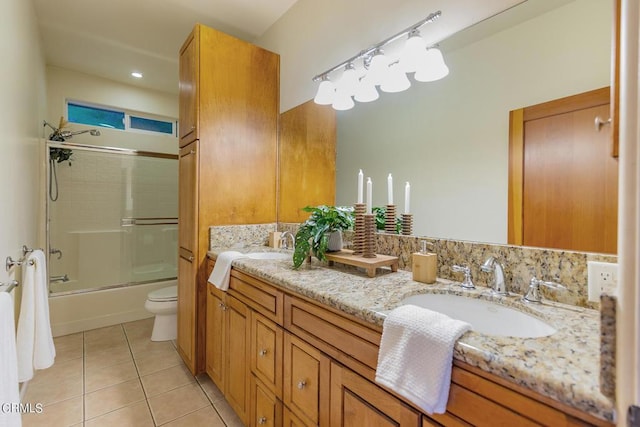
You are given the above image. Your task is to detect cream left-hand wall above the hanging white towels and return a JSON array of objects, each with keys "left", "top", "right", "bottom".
[{"left": 0, "top": 0, "right": 46, "bottom": 306}]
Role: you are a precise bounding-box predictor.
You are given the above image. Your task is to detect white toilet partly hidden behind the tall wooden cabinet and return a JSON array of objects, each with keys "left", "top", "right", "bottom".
[{"left": 144, "top": 285, "right": 178, "bottom": 341}]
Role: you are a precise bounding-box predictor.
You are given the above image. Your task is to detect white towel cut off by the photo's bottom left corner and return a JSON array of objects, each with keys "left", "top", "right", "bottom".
[{"left": 0, "top": 292, "right": 22, "bottom": 427}]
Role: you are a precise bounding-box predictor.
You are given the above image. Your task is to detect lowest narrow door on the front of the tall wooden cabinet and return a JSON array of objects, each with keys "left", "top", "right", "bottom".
[{"left": 176, "top": 248, "right": 198, "bottom": 373}]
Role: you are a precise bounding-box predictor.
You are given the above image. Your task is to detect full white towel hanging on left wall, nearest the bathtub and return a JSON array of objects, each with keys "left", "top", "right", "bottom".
[{"left": 17, "top": 249, "right": 56, "bottom": 382}]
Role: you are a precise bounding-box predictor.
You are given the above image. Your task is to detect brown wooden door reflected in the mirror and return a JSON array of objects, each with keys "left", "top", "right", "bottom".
[{"left": 509, "top": 88, "right": 618, "bottom": 253}]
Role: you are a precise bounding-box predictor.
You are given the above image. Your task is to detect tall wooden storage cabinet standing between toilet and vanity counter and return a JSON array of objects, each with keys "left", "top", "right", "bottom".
[{"left": 177, "top": 24, "right": 280, "bottom": 373}]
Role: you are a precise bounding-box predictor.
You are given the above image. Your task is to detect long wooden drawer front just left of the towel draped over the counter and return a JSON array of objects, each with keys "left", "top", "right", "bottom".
[{"left": 284, "top": 295, "right": 381, "bottom": 377}]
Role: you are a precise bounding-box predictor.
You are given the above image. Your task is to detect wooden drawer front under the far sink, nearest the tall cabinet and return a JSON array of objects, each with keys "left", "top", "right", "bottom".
[{"left": 229, "top": 270, "right": 284, "bottom": 325}]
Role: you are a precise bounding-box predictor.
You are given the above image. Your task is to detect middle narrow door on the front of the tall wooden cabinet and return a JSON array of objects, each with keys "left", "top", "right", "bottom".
[{"left": 178, "top": 141, "right": 198, "bottom": 255}]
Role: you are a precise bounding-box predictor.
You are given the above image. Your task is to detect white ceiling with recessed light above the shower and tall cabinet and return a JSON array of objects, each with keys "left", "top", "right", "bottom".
[{"left": 33, "top": 0, "right": 296, "bottom": 93}]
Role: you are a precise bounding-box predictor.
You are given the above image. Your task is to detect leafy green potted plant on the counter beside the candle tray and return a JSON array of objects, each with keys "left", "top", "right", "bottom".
[{"left": 293, "top": 205, "right": 353, "bottom": 268}]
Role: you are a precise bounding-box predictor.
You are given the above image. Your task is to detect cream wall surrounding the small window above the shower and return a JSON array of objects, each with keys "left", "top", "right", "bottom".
[{"left": 45, "top": 66, "right": 178, "bottom": 154}]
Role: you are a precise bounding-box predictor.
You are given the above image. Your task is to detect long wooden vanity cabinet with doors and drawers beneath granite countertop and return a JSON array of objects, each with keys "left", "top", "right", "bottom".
[{"left": 207, "top": 260, "right": 612, "bottom": 427}]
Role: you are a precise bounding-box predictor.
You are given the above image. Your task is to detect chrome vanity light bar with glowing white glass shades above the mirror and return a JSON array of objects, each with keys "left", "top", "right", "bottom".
[{"left": 313, "top": 11, "right": 449, "bottom": 110}]
